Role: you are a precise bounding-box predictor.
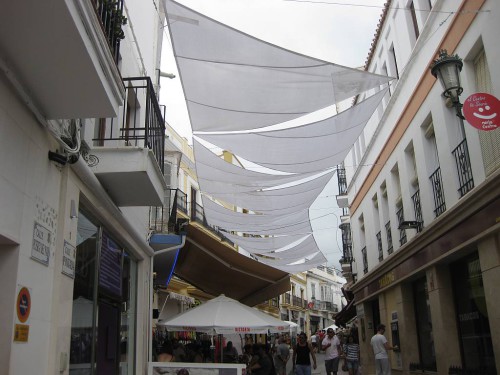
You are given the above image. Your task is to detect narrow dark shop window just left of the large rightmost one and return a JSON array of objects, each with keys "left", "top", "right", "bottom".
[{"left": 413, "top": 277, "right": 437, "bottom": 371}]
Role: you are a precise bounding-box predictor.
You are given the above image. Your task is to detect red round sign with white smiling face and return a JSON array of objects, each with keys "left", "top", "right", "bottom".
[{"left": 463, "top": 92, "right": 500, "bottom": 131}]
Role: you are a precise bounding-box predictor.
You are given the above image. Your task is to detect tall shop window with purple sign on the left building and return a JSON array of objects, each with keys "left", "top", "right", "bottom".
[{"left": 70, "top": 212, "right": 137, "bottom": 375}]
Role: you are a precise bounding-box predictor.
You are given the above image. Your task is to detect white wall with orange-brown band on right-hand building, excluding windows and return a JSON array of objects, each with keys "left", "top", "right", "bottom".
[{"left": 345, "top": 0, "right": 500, "bottom": 374}]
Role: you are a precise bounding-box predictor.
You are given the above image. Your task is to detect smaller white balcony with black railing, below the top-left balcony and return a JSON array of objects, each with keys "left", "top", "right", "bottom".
[{"left": 90, "top": 77, "right": 166, "bottom": 207}]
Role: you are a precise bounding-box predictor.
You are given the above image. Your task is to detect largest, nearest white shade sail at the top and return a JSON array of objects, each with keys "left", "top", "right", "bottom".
[{"left": 165, "top": 0, "right": 392, "bottom": 132}]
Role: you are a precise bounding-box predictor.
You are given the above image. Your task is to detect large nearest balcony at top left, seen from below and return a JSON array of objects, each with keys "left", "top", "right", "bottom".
[{"left": 0, "top": 0, "right": 125, "bottom": 119}]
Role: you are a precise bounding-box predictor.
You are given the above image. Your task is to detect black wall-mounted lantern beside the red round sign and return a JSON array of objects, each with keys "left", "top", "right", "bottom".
[{"left": 431, "top": 49, "right": 465, "bottom": 120}]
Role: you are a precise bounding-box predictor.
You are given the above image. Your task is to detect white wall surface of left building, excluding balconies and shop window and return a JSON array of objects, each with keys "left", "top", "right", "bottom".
[{"left": 0, "top": 1, "right": 166, "bottom": 374}]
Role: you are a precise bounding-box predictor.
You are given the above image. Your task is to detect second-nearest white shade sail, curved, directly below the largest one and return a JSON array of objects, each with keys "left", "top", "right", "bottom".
[{"left": 198, "top": 90, "right": 387, "bottom": 173}]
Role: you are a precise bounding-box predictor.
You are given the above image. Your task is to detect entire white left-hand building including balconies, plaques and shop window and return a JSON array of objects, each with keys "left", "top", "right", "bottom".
[{"left": 0, "top": 0, "right": 170, "bottom": 375}]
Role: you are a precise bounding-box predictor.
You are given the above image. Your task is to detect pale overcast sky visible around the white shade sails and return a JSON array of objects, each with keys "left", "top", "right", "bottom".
[{"left": 159, "top": 0, "right": 386, "bottom": 269}]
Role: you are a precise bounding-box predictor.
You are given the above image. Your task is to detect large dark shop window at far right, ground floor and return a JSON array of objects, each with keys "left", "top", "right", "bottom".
[{"left": 451, "top": 253, "right": 496, "bottom": 374}]
